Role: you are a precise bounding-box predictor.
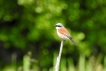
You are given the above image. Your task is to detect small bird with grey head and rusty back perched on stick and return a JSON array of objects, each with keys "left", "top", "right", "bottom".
[{"left": 55, "top": 23, "right": 77, "bottom": 44}]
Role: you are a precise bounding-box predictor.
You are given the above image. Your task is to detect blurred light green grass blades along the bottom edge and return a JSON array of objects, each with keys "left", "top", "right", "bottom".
[{"left": 3, "top": 52, "right": 106, "bottom": 71}]
